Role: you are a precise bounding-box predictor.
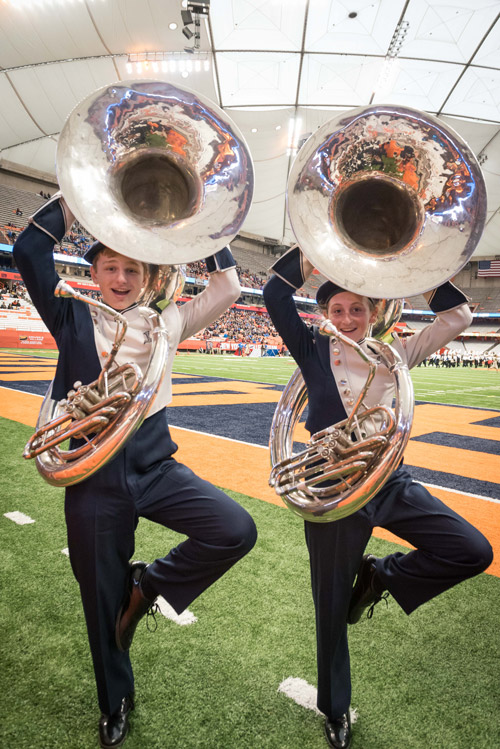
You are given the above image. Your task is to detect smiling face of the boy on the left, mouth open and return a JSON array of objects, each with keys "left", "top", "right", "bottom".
[{"left": 90, "top": 248, "right": 146, "bottom": 311}]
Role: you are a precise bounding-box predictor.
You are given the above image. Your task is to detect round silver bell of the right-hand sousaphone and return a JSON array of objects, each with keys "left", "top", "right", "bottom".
[{"left": 287, "top": 106, "right": 486, "bottom": 298}]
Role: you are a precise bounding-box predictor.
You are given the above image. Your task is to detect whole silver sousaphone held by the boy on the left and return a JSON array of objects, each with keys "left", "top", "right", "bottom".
[{"left": 24, "top": 80, "right": 253, "bottom": 486}]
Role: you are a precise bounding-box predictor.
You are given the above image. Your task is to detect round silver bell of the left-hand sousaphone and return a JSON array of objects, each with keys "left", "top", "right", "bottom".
[{"left": 57, "top": 80, "right": 253, "bottom": 265}]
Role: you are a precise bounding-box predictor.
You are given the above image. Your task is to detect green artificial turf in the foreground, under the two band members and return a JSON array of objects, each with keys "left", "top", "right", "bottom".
[{"left": 0, "top": 418, "right": 500, "bottom": 749}]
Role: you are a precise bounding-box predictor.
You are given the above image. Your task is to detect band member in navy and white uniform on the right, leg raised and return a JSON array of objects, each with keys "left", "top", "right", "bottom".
[{"left": 264, "top": 247, "right": 492, "bottom": 749}]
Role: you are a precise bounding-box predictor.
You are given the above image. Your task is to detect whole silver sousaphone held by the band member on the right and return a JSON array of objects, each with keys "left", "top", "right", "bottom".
[{"left": 270, "top": 106, "right": 486, "bottom": 522}]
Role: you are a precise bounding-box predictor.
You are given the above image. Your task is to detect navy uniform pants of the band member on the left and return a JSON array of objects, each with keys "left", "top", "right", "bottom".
[{"left": 65, "top": 413, "right": 257, "bottom": 715}]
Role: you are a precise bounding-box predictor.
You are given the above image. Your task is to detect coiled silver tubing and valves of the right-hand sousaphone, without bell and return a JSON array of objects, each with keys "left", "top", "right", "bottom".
[{"left": 269, "top": 320, "right": 414, "bottom": 523}]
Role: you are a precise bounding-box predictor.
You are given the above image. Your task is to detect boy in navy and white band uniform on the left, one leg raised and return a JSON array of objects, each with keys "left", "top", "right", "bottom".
[{"left": 14, "top": 194, "right": 256, "bottom": 747}]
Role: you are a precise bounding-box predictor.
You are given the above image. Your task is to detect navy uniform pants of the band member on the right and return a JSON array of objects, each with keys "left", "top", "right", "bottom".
[{"left": 305, "top": 468, "right": 493, "bottom": 718}]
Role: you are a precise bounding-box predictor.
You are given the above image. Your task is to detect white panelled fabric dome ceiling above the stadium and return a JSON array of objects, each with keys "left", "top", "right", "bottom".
[{"left": 0, "top": 0, "right": 500, "bottom": 258}]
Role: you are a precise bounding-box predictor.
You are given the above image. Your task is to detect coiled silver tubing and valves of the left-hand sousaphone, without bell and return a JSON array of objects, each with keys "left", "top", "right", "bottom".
[{"left": 23, "top": 281, "right": 168, "bottom": 486}]
